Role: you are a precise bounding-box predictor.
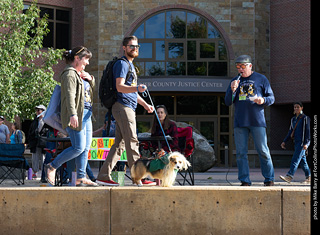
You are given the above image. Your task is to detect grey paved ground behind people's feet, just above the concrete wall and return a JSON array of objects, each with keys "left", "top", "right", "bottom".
[{"left": 0, "top": 167, "right": 310, "bottom": 188}]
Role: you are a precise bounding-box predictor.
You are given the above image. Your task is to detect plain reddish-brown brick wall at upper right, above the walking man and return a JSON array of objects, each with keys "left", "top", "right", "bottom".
[{"left": 270, "top": 0, "right": 311, "bottom": 104}]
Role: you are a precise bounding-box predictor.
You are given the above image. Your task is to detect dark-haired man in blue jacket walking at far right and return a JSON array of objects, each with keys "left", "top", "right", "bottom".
[{"left": 280, "top": 102, "right": 311, "bottom": 184}]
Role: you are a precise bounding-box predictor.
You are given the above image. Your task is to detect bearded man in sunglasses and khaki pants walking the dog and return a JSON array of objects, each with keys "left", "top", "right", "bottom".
[{"left": 96, "top": 36, "right": 155, "bottom": 186}]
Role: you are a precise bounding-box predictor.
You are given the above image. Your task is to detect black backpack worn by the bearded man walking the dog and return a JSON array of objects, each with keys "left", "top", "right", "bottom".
[{"left": 99, "top": 57, "right": 133, "bottom": 111}]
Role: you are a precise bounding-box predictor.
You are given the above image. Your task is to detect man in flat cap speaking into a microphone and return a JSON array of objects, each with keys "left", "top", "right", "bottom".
[{"left": 225, "top": 55, "right": 274, "bottom": 186}]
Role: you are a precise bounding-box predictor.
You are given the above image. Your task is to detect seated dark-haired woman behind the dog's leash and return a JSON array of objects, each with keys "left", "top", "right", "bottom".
[{"left": 151, "top": 105, "right": 179, "bottom": 152}]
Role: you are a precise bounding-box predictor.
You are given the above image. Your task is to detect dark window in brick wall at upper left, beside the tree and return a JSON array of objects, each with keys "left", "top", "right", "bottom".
[{"left": 24, "top": 4, "right": 71, "bottom": 49}]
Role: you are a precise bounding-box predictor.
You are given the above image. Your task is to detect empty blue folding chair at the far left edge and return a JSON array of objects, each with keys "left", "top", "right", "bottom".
[{"left": 0, "top": 144, "right": 30, "bottom": 185}]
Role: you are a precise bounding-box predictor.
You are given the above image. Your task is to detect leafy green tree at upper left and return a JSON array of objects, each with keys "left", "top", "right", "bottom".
[{"left": 0, "top": 0, "right": 62, "bottom": 121}]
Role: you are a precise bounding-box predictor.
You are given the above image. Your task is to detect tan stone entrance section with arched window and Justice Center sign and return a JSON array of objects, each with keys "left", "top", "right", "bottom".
[{"left": 84, "top": 0, "right": 270, "bottom": 164}]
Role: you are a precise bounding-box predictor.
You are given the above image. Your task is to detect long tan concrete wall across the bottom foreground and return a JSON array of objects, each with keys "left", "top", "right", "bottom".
[{"left": 0, "top": 187, "right": 311, "bottom": 235}]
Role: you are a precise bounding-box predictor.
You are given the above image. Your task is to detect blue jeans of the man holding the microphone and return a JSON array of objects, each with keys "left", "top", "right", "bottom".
[{"left": 234, "top": 126, "right": 274, "bottom": 185}]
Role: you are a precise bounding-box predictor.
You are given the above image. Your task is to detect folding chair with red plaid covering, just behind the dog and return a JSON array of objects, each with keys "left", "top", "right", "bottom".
[{"left": 177, "top": 126, "right": 194, "bottom": 185}]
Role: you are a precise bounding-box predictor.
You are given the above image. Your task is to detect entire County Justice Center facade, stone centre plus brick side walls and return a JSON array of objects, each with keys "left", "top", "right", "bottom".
[{"left": 21, "top": 0, "right": 311, "bottom": 165}]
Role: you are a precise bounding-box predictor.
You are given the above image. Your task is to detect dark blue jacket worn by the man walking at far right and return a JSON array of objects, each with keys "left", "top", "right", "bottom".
[{"left": 283, "top": 113, "right": 310, "bottom": 147}]
